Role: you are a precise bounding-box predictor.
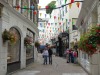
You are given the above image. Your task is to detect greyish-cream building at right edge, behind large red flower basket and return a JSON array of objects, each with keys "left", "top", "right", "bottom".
[{"left": 76, "top": 0, "right": 100, "bottom": 75}]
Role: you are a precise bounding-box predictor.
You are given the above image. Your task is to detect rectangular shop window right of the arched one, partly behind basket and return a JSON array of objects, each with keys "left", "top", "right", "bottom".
[{"left": 26, "top": 29, "right": 35, "bottom": 65}]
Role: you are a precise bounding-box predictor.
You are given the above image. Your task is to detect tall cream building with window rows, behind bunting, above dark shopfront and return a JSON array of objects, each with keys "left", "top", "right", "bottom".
[{"left": 57, "top": 0, "right": 82, "bottom": 48}]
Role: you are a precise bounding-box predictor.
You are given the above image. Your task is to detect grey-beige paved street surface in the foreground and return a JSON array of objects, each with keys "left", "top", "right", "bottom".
[{"left": 12, "top": 54, "right": 87, "bottom": 75}]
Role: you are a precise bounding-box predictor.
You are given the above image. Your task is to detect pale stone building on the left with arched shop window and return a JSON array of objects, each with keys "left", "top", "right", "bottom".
[{"left": 0, "top": 0, "right": 39, "bottom": 75}]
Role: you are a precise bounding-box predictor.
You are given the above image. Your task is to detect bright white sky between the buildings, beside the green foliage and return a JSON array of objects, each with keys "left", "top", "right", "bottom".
[{"left": 38, "top": 0, "right": 56, "bottom": 18}]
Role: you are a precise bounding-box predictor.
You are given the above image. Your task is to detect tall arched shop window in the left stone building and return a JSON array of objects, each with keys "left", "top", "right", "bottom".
[{"left": 7, "top": 27, "right": 21, "bottom": 73}]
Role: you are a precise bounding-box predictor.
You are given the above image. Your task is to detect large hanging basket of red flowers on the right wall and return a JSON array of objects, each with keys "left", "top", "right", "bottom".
[{"left": 78, "top": 25, "right": 100, "bottom": 55}]
